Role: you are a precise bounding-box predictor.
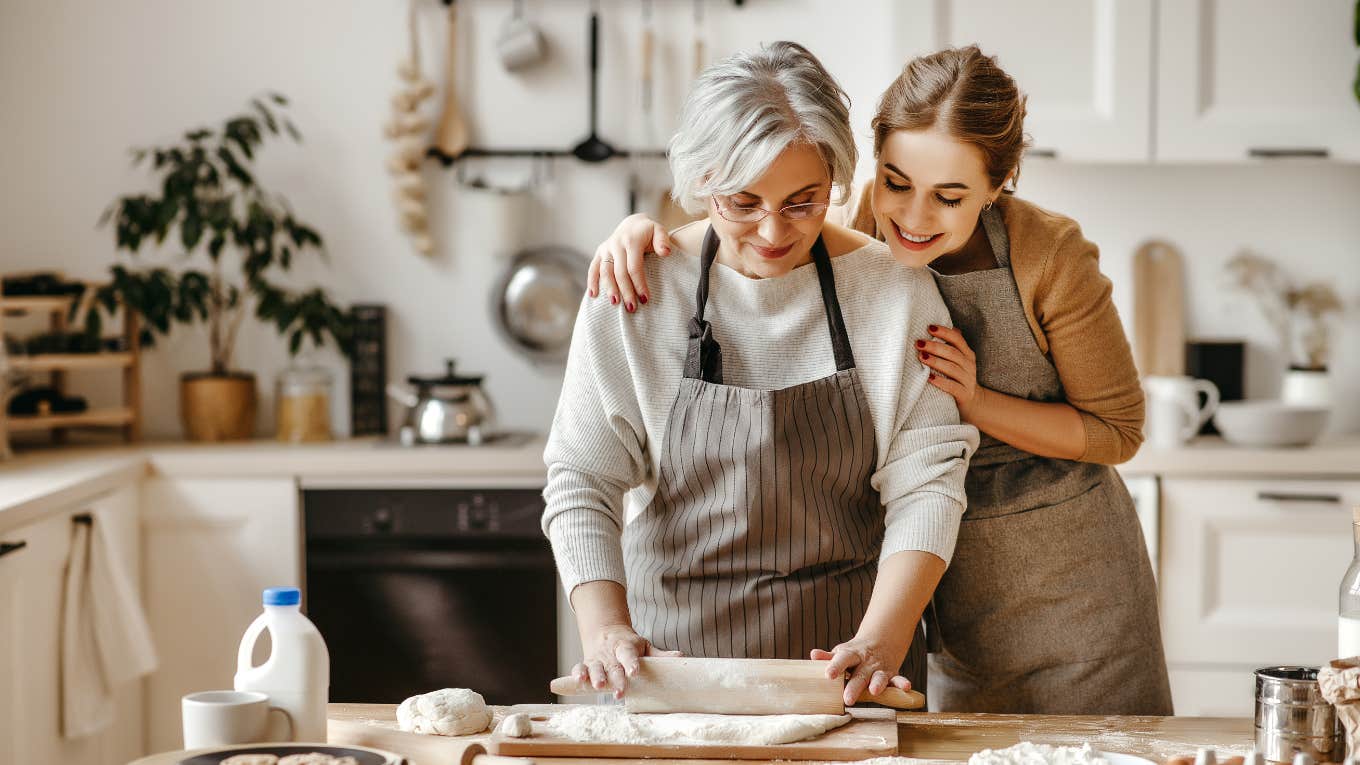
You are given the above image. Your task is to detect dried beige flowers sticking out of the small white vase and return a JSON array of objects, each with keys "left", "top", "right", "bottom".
[{"left": 1227, "top": 252, "right": 1344, "bottom": 370}]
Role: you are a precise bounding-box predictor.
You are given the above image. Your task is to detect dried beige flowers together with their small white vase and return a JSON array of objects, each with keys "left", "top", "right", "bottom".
[{"left": 1227, "top": 252, "right": 1342, "bottom": 406}]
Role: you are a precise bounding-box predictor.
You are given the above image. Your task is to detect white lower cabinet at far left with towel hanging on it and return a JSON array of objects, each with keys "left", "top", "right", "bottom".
[{"left": 0, "top": 485, "right": 146, "bottom": 765}]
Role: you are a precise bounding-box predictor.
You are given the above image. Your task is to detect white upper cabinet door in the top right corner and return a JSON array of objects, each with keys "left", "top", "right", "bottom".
[{"left": 1156, "top": 0, "right": 1360, "bottom": 162}]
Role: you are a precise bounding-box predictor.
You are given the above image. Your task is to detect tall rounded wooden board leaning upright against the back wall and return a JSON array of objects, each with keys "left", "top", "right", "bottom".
[{"left": 1133, "top": 240, "right": 1186, "bottom": 377}]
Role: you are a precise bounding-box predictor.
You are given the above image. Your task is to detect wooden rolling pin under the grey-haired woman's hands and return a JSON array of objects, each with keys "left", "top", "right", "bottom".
[{"left": 548, "top": 656, "right": 926, "bottom": 715}]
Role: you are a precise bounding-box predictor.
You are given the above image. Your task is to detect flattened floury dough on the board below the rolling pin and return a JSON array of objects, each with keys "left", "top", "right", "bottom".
[{"left": 549, "top": 705, "right": 850, "bottom": 745}]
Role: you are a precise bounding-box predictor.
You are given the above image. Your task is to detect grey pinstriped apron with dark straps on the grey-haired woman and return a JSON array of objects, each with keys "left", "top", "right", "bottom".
[{"left": 624, "top": 229, "right": 925, "bottom": 687}]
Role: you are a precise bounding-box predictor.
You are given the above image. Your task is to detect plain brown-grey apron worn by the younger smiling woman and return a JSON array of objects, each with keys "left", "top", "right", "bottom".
[{"left": 928, "top": 205, "right": 1171, "bottom": 715}]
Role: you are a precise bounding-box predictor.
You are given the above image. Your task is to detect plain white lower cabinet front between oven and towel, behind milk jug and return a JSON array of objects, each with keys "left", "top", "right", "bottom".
[{"left": 143, "top": 475, "right": 302, "bottom": 751}]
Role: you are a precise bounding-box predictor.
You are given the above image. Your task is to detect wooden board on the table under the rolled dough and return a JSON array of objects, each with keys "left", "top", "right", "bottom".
[{"left": 495, "top": 704, "right": 898, "bottom": 765}]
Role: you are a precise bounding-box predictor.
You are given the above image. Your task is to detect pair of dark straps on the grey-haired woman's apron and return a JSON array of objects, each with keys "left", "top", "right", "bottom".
[{"left": 684, "top": 226, "right": 854, "bottom": 385}]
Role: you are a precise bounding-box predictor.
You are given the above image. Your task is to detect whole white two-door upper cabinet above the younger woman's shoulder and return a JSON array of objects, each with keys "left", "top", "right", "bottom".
[{"left": 884, "top": 0, "right": 1360, "bottom": 162}]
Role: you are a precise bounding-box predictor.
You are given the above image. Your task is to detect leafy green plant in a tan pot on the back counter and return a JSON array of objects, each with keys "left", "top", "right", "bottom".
[{"left": 86, "top": 94, "right": 352, "bottom": 441}]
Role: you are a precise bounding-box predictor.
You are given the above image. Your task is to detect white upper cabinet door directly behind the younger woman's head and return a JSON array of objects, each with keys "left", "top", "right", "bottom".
[{"left": 884, "top": 0, "right": 1153, "bottom": 162}]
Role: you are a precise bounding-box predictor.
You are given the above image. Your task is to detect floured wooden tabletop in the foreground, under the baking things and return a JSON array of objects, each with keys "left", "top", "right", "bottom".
[{"left": 127, "top": 704, "right": 1253, "bottom": 765}]
